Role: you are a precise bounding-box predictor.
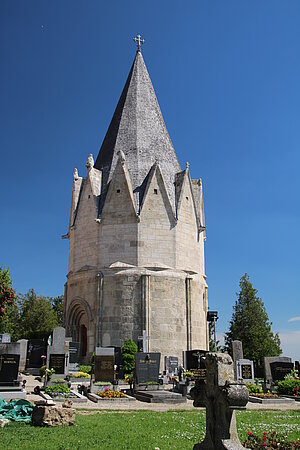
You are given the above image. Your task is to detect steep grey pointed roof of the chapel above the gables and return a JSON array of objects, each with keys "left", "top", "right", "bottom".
[{"left": 95, "top": 50, "right": 181, "bottom": 210}]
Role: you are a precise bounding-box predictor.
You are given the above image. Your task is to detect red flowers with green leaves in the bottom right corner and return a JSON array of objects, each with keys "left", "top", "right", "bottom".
[{"left": 243, "top": 431, "right": 300, "bottom": 450}]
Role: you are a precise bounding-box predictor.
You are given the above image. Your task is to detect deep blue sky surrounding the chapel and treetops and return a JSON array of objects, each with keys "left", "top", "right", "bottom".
[{"left": 0, "top": 0, "right": 300, "bottom": 359}]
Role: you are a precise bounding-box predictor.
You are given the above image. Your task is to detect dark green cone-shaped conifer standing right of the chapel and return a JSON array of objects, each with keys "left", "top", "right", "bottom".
[{"left": 225, "top": 274, "right": 281, "bottom": 360}]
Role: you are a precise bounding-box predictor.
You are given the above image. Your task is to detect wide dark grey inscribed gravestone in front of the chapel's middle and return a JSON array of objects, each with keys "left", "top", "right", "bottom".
[{"left": 134, "top": 352, "right": 160, "bottom": 384}]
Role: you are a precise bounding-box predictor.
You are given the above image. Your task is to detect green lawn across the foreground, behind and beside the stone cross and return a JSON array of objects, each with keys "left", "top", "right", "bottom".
[{"left": 0, "top": 410, "right": 300, "bottom": 450}]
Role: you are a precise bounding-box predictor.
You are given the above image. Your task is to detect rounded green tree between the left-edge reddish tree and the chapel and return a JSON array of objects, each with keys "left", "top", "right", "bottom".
[{"left": 19, "top": 289, "right": 59, "bottom": 339}]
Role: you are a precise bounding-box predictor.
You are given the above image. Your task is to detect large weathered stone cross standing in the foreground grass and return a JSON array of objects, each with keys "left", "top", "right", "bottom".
[{"left": 191, "top": 353, "right": 249, "bottom": 450}]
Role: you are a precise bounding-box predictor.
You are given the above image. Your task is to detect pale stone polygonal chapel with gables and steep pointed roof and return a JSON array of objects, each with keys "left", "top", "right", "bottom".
[{"left": 64, "top": 39, "right": 209, "bottom": 362}]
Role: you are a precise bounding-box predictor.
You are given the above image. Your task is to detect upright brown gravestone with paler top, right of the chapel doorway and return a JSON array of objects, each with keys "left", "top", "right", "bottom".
[{"left": 94, "top": 347, "right": 115, "bottom": 383}]
